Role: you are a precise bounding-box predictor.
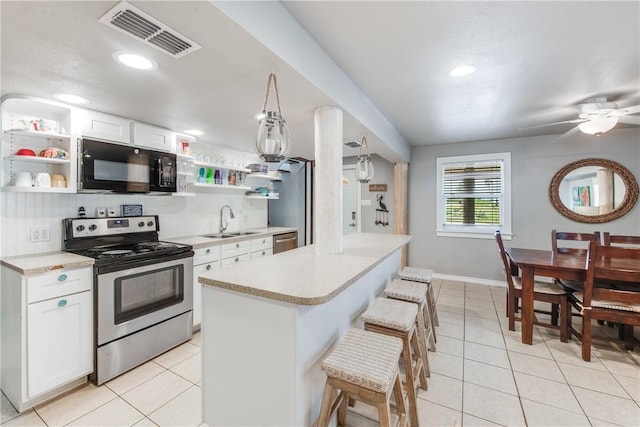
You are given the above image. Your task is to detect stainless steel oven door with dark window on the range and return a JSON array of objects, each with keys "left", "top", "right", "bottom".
[{"left": 95, "top": 257, "right": 193, "bottom": 346}]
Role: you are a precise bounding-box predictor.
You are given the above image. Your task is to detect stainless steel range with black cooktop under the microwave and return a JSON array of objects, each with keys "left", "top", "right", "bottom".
[{"left": 63, "top": 216, "right": 193, "bottom": 384}]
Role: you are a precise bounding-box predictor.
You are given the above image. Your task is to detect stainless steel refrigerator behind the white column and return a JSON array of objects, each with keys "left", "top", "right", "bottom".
[{"left": 269, "top": 159, "right": 313, "bottom": 247}]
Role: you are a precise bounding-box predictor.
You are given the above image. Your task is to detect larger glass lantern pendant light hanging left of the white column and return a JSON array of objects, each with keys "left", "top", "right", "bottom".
[{"left": 256, "top": 73, "right": 291, "bottom": 162}]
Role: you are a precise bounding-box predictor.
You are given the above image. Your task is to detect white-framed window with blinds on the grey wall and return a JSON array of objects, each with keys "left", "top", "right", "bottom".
[{"left": 436, "top": 153, "right": 511, "bottom": 238}]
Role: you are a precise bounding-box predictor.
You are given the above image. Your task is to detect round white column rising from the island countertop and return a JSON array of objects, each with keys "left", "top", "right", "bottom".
[{"left": 313, "top": 107, "right": 343, "bottom": 254}]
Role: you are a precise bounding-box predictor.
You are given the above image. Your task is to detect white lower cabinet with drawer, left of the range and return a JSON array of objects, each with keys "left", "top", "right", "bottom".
[{"left": 1, "top": 266, "right": 93, "bottom": 412}]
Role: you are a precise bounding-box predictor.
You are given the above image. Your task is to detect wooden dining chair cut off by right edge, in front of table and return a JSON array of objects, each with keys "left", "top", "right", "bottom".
[{"left": 570, "top": 242, "right": 640, "bottom": 361}]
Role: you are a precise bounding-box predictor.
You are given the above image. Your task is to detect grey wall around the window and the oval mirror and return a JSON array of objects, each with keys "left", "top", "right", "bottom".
[{"left": 409, "top": 128, "right": 640, "bottom": 280}]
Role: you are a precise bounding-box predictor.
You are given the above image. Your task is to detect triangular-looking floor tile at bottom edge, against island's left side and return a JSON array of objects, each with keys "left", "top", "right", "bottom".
[{"left": 149, "top": 386, "right": 202, "bottom": 426}]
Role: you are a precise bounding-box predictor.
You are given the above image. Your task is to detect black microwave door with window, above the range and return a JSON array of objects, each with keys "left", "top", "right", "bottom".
[{"left": 78, "top": 138, "right": 151, "bottom": 193}]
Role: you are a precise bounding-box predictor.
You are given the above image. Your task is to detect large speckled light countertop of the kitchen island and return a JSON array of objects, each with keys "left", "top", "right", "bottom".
[{"left": 198, "top": 233, "right": 411, "bottom": 305}]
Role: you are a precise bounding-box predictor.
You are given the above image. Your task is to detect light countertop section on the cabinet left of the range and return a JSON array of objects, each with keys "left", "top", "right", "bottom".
[{"left": 0, "top": 251, "right": 94, "bottom": 275}]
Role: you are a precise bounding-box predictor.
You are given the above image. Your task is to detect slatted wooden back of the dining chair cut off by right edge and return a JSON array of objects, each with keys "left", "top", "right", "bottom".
[{"left": 584, "top": 242, "right": 640, "bottom": 306}]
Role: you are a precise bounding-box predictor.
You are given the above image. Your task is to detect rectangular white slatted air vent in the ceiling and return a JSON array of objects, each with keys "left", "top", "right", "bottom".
[{"left": 100, "top": 1, "right": 201, "bottom": 58}]
